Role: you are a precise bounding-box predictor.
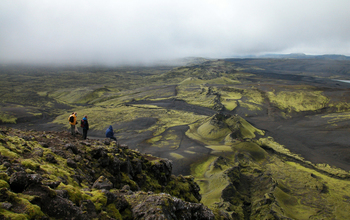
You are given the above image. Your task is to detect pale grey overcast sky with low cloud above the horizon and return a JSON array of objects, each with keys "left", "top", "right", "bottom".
[{"left": 0, "top": 0, "right": 350, "bottom": 65}]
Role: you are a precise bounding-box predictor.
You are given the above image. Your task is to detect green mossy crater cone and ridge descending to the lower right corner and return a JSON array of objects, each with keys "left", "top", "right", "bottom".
[{"left": 188, "top": 115, "right": 350, "bottom": 219}]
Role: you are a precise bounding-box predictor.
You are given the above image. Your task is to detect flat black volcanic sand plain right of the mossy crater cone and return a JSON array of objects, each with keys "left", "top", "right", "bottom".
[{"left": 247, "top": 113, "right": 350, "bottom": 171}]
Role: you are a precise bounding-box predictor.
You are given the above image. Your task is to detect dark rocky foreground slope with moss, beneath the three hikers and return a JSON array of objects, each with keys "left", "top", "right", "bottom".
[{"left": 0, "top": 129, "right": 214, "bottom": 219}]
